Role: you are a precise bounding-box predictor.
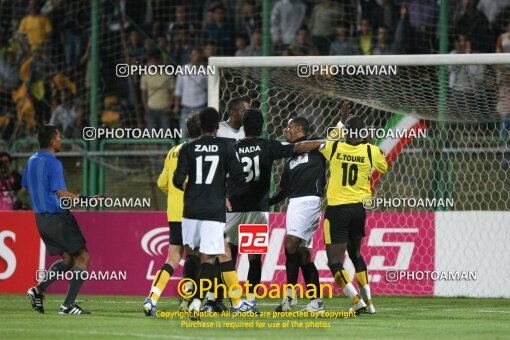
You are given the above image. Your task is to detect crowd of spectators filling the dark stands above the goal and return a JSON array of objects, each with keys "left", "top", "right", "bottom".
[{"left": 0, "top": 0, "right": 510, "bottom": 141}]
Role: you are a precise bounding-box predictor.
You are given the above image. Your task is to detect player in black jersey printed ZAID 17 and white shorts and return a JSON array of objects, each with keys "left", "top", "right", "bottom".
[{"left": 173, "top": 107, "right": 253, "bottom": 320}]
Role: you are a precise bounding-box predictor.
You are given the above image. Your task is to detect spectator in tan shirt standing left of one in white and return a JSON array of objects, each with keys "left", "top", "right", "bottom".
[{"left": 140, "top": 55, "right": 175, "bottom": 129}]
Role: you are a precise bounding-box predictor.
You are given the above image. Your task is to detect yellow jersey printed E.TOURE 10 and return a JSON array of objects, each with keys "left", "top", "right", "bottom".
[{"left": 319, "top": 141, "right": 388, "bottom": 205}]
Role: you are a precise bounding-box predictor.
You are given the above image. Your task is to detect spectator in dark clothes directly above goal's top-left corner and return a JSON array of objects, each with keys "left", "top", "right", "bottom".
[{"left": 204, "top": 5, "right": 234, "bottom": 55}]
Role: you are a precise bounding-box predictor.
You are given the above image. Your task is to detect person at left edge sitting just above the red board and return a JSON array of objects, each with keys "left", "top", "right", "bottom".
[{"left": 0, "top": 152, "right": 22, "bottom": 210}]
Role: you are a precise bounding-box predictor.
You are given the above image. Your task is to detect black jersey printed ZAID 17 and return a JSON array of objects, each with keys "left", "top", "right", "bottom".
[{"left": 173, "top": 136, "right": 246, "bottom": 223}]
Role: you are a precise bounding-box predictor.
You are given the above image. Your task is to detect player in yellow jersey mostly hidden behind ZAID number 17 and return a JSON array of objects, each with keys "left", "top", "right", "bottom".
[{"left": 143, "top": 113, "right": 200, "bottom": 316}]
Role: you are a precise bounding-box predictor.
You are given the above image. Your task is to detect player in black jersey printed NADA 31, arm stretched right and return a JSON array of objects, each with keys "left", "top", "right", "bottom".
[{"left": 225, "top": 110, "right": 322, "bottom": 305}]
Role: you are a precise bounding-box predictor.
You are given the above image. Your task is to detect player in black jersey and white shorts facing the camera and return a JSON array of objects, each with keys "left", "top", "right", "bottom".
[{"left": 269, "top": 117, "right": 326, "bottom": 313}]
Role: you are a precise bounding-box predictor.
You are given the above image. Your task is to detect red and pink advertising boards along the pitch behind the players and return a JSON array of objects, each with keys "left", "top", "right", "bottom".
[{"left": 0, "top": 212, "right": 435, "bottom": 296}]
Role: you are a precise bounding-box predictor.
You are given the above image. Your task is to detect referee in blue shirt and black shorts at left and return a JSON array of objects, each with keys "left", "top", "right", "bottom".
[{"left": 22, "top": 125, "right": 90, "bottom": 314}]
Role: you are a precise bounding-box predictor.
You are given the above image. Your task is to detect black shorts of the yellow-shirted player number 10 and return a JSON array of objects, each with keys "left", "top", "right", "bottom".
[{"left": 324, "top": 203, "right": 366, "bottom": 244}]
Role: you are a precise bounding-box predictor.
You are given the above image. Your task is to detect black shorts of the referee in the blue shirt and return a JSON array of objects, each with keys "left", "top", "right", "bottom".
[{"left": 35, "top": 211, "right": 86, "bottom": 256}]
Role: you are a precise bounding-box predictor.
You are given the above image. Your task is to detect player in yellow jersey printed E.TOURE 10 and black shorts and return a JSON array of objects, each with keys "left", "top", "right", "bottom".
[{"left": 319, "top": 116, "right": 388, "bottom": 314}]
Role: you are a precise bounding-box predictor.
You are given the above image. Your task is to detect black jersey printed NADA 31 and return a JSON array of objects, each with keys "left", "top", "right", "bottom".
[{"left": 229, "top": 138, "right": 294, "bottom": 212}]
